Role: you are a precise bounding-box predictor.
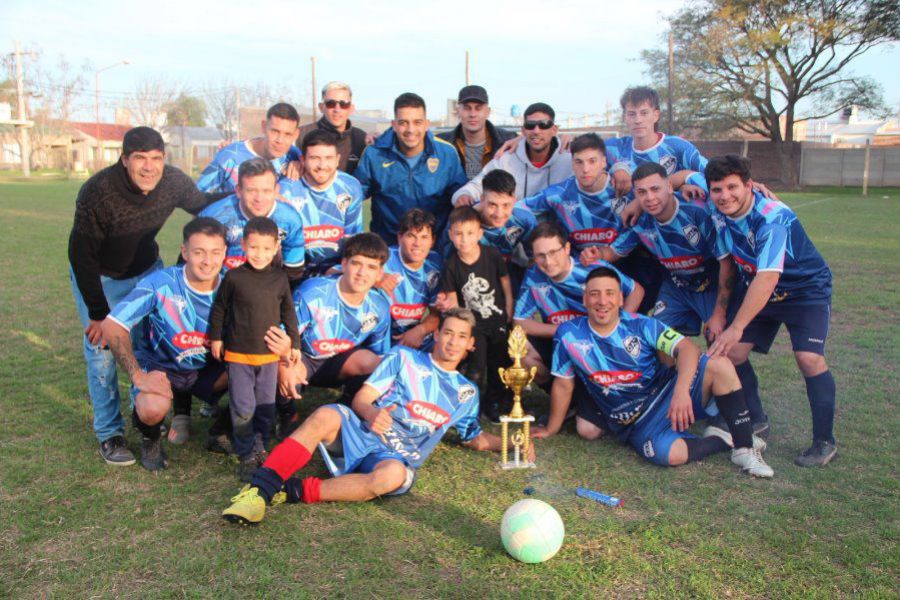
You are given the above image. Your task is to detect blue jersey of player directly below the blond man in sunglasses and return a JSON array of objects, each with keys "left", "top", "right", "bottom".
[{"left": 279, "top": 171, "right": 363, "bottom": 273}]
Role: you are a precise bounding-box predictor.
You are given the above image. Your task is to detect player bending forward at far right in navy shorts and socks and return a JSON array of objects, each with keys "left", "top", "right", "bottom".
[{"left": 706, "top": 156, "right": 837, "bottom": 467}]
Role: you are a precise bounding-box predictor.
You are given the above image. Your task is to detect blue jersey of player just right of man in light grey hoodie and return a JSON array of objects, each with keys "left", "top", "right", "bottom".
[{"left": 522, "top": 176, "right": 627, "bottom": 255}]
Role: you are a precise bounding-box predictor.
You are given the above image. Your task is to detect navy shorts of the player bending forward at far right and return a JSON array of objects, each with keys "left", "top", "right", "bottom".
[{"left": 729, "top": 302, "right": 831, "bottom": 356}]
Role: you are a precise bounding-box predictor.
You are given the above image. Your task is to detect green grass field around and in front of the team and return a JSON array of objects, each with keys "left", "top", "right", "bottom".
[{"left": 0, "top": 181, "right": 900, "bottom": 598}]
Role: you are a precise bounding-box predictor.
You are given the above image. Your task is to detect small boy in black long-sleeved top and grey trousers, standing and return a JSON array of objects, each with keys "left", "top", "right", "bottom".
[{"left": 209, "top": 217, "right": 300, "bottom": 481}]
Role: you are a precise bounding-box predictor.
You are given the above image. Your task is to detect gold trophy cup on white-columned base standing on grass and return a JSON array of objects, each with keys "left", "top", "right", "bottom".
[{"left": 500, "top": 325, "right": 537, "bottom": 469}]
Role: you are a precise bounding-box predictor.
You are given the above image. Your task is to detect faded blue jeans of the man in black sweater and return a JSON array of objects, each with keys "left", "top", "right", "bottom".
[{"left": 69, "top": 260, "right": 163, "bottom": 442}]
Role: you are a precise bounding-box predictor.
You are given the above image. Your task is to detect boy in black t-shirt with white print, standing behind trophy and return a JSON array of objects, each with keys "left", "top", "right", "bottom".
[{"left": 440, "top": 206, "right": 513, "bottom": 423}]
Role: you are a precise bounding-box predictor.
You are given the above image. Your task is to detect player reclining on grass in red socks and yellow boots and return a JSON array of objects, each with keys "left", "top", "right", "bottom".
[{"left": 222, "top": 308, "right": 534, "bottom": 524}]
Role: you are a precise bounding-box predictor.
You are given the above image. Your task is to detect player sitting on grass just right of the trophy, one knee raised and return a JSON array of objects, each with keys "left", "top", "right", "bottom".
[{"left": 532, "top": 267, "right": 773, "bottom": 477}]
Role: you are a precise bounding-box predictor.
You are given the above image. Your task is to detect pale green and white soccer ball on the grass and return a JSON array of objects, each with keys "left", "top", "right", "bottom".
[{"left": 500, "top": 499, "right": 565, "bottom": 563}]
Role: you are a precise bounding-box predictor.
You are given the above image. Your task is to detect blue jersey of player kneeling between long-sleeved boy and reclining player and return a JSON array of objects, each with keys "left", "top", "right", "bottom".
[{"left": 294, "top": 277, "right": 391, "bottom": 359}]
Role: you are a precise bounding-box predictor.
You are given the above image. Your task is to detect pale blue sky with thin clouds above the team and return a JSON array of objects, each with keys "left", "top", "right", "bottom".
[{"left": 0, "top": 0, "right": 900, "bottom": 124}]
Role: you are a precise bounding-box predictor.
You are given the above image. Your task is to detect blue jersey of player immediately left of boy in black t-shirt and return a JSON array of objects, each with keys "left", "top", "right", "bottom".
[{"left": 381, "top": 246, "right": 443, "bottom": 338}]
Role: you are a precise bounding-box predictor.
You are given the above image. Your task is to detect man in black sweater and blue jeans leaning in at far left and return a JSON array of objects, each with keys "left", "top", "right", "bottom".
[{"left": 69, "top": 127, "right": 214, "bottom": 465}]
